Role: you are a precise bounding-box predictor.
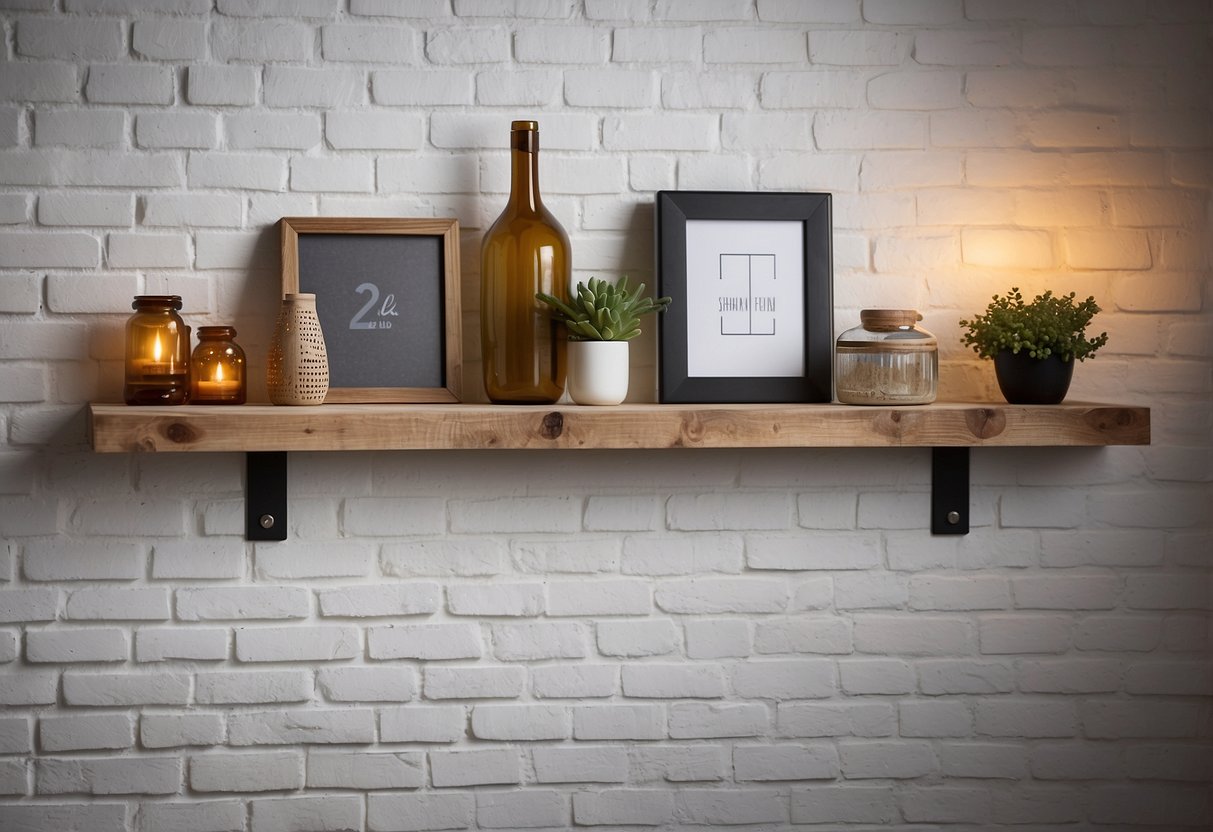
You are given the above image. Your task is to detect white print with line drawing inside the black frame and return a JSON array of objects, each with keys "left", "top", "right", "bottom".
[{"left": 685, "top": 220, "right": 805, "bottom": 378}]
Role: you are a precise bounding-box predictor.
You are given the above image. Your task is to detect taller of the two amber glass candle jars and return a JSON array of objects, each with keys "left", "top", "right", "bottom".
[{"left": 123, "top": 295, "right": 189, "bottom": 404}]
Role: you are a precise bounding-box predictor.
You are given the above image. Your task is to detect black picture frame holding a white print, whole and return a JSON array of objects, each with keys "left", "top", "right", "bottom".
[{"left": 656, "top": 190, "right": 833, "bottom": 404}]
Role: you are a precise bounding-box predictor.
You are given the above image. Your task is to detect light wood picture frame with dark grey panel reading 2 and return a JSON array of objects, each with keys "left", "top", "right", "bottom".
[{"left": 279, "top": 217, "right": 463, "bottom": 404}]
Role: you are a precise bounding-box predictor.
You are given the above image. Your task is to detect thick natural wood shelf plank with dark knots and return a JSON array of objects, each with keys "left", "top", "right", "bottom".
[{"left": 89, "top": 403, "right": 1150, "bottom": 454}]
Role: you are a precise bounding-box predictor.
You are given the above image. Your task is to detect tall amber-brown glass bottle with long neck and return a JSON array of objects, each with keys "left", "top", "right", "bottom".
[{"left": 480, "top": 121, "right": 573, "bottom": 404}]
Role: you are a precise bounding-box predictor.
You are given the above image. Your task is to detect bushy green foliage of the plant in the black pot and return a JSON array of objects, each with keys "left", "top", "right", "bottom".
[{"left": 961, "top": 287, "right": 1107, "bottom": 361}]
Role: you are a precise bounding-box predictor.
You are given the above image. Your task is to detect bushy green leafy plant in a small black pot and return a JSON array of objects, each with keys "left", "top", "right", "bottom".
[{"left": 961, "top": 287, "right": 1107, "bottom": 404}]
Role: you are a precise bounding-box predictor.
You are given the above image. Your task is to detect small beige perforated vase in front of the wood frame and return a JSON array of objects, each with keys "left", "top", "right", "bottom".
[{"left": 266, "top": 294, "right": 329, "bottom": 405}]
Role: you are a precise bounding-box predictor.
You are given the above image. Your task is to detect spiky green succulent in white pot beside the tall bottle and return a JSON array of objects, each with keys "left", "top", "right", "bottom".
[{"left": 535, "top": 277, "right": 670, "bottom": 404}]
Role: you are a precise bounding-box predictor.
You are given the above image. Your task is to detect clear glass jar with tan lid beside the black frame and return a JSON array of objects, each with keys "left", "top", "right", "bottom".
[{"left": 835, "top": 309, "right": 939, "bottom": 404}]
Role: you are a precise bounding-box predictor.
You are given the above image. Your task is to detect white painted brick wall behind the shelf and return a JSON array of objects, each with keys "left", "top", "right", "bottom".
[{"left": 0, "top": 0, "right": 1213, "bottom": 832}]
